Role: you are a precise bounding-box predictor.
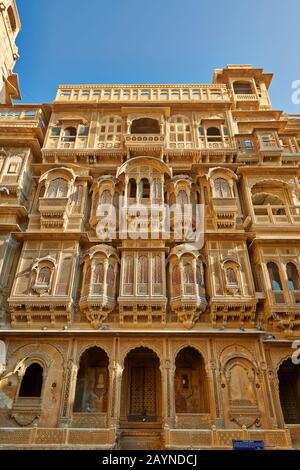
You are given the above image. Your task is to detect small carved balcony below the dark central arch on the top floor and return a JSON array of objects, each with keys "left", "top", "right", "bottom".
[{"left": 124, "top": 134, "right": 165, "bottom": 157}]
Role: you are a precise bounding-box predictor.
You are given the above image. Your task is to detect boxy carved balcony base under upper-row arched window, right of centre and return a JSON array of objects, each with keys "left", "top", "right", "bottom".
[{"left": 212, "top": 197, "right": 238, "bottom": 230}]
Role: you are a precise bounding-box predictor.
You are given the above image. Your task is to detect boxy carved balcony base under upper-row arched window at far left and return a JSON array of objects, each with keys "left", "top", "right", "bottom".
[{"left": 39, "top": 197, "right": 69, "bottom": 229}]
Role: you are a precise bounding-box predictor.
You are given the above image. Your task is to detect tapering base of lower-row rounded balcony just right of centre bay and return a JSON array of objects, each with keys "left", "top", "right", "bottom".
[{"left": 170, "top": 284, "right": 207, "bottom": 328}]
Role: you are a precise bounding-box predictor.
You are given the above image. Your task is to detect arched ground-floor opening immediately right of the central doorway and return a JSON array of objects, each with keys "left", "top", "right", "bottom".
[{"left": 175, "top": 346, "right": 209, "bottom": 414}]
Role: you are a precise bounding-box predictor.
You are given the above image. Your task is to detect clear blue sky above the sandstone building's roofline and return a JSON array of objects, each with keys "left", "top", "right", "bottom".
[{"left": 15, "top": 0, "right": 300, "bottom": 113}]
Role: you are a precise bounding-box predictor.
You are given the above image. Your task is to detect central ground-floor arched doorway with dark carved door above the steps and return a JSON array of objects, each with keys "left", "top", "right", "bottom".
[{"left": 121, "top": 347, "right": 161, "bottom": 426}]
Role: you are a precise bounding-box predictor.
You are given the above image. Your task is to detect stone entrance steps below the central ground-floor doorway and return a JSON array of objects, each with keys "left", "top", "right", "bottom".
[{"left": 119, "top": 429, "right": 164, "bottom": 450}]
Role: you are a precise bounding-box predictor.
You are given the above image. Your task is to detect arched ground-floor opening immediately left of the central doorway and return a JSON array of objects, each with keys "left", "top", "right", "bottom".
[{"left": 73, "top": 346, "right": 109, "bottom": 413}]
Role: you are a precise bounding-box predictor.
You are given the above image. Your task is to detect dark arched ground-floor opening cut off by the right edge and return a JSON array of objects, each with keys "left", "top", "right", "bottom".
[{"left": 278, "top": 359, "right": 300, "bottom": 424}]
